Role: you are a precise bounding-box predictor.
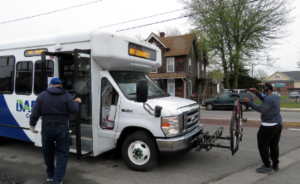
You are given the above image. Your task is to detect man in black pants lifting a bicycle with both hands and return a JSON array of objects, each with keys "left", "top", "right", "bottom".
[{"left": 243, "top": 83, "right": 282, "bottom": 173}]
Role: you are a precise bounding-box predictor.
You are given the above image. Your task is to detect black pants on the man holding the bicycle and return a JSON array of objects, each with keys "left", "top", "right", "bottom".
[{"left": 257, "top": 124, "right": 282, "bottom": 167}]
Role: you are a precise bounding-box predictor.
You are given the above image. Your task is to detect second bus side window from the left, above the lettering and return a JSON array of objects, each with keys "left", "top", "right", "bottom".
[{"left": 15, "top": 61, "right": 33, "bottom": 95}]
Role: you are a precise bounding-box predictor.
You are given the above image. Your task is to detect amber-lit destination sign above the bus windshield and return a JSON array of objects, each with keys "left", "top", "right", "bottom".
[{"left": 128, "top": 43, "right": 156, "bottom": 61}]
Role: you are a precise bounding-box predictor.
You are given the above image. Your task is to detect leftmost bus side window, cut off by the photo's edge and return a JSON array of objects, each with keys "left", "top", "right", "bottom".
[{"left": 0, "top": 56, "right": 15, "bottom": 94}]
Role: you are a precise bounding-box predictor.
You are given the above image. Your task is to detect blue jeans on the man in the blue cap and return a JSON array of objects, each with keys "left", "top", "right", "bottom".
[{"left": 42, "top": 124, "right": 69, "bottom": 183}]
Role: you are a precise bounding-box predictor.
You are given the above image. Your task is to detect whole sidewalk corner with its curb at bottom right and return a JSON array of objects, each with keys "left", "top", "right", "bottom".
[{"left": 210, "top": 148, "right": 300, "bottom": 184}]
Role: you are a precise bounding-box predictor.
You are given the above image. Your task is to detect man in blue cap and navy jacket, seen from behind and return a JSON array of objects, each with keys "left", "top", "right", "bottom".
[{"left": 30, "top": 78, "right": 81, "bottom": 184}]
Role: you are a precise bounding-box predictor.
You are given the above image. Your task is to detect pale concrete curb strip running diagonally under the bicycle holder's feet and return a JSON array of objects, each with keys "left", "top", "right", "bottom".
[{"left": 209, "top": 148, "right": 300, "bottom": 184}]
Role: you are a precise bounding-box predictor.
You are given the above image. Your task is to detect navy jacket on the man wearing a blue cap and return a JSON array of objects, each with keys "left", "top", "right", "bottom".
[{"left": 30, "top": 87, "right": 79, "bottom": 126}]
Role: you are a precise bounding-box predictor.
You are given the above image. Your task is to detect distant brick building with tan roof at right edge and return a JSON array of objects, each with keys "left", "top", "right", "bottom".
[{"left": 263, "top": 71, "right": 300, "bottom": 95}]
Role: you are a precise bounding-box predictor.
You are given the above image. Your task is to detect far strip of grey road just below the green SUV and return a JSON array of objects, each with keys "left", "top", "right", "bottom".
[{"left": 200, "top": 109, "right": 300, "bottom": 122}]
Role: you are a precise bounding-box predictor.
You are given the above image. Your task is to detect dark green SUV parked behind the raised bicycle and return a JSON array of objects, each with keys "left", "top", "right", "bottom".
[{"left": 202, "top": 91, "right": 254, "bottom": 111}]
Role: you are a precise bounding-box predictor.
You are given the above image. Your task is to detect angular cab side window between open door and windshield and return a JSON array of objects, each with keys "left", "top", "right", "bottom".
[{"left": 100, "top": 78, "right": 119, "bottom": 129}]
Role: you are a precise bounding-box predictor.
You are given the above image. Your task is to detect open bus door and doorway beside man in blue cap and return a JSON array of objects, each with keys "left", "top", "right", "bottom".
[{"left": 41, "top": 49, "right": 93, "bottom": 159}]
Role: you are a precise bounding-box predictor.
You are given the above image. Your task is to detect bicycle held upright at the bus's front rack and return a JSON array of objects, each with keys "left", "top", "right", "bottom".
[{"left": 229, "top": 89, "right": 250, "bottom": 155}]
